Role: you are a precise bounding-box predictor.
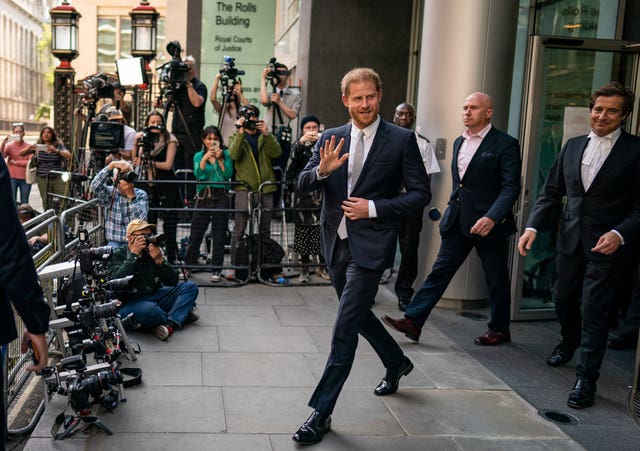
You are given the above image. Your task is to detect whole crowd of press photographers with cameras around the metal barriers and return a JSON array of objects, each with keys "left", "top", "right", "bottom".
[{"left": 0, "top": 41, "right": 338, "bottom": 443}]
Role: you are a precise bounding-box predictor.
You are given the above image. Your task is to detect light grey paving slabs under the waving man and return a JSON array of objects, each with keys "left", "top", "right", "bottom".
[{"left": 24, "top": 282, "right": 583, "bottom": 451}]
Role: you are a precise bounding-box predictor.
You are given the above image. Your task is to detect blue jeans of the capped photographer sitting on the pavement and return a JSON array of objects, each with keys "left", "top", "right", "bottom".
[{"left": 120, "top": 282, "right": 198, "bottom": 329}]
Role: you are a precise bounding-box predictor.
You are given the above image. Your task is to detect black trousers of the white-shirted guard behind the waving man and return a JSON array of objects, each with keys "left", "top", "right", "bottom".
[{"left": 394, "top": 209, "right": 424, "bottom": 298}]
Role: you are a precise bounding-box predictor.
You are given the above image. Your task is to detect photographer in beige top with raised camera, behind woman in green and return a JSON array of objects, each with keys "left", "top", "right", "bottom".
[{"left": 210, "top": 69, "right": 249, "bottom": 142}]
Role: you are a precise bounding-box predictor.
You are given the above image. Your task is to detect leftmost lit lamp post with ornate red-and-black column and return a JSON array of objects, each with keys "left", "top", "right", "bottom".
[{"left": 49, "top": 0, "right": 80, "bottom": 152}]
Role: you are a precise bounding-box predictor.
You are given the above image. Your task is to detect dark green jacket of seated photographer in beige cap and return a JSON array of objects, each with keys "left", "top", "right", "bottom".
[{"left": 108, "top": 247, "right": 178, "bottom": 302}]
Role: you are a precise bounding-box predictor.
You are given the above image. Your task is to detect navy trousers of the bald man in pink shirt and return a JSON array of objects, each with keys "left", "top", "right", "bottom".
[{"left": 405, "top": 220, "right": 511, "bottom": 332}]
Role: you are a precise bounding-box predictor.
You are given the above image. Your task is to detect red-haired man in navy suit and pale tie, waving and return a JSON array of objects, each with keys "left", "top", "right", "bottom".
[{"left": 293, "top": 68, "right": 431, "bottom": 444}]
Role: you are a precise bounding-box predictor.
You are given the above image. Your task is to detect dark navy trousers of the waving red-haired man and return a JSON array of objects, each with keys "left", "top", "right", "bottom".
[{"left": 309, "top": 239, "right": 404, "bottom": 415}]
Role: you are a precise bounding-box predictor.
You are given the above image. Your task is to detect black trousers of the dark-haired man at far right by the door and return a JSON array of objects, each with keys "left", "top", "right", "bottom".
[{"left": 554, "top": 249, "right": 625, "bottom": 382}]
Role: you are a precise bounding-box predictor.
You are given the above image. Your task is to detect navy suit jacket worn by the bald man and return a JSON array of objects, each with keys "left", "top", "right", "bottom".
[{"left": 440, "top": 127, "right": 521, "bottom": 239}]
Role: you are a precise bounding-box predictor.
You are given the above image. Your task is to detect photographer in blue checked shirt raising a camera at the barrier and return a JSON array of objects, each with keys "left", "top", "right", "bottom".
[{"left": 91, "top": 160, "right": 149, "bottom": 248}]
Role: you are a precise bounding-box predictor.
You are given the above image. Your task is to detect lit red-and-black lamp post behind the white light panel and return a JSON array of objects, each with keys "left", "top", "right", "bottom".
[{"left": 129, "top": 0, "right": 160, "bottom": 128}]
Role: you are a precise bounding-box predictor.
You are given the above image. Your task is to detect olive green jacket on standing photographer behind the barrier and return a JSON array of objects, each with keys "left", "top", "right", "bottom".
[{"left": 229, "top": 132, "right": 282, "bottom": 193}]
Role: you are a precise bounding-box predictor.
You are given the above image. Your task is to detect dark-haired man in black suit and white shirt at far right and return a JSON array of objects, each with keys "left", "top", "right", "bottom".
[{"left": 518, "top": 82, "right": 640, "bottom": 409}]
